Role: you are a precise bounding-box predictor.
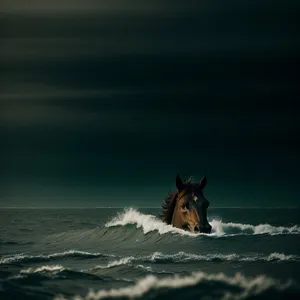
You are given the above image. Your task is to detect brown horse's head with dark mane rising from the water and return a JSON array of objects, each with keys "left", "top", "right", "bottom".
[{"left": 161, "top": 175, "right": 211, "bottom": 233}]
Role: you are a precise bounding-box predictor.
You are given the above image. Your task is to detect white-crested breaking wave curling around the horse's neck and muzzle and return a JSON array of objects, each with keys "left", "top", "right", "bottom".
[{"left": 105, "top": 208, "right": 300, "bottom": 237}]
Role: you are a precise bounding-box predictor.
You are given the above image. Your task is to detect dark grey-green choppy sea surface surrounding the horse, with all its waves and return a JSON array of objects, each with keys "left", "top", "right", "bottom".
[{"left": 0, "top": 208, "right": 300, "bottom": 300}]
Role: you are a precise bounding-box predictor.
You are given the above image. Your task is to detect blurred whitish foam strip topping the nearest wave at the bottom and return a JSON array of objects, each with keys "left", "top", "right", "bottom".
[{"left": 55, "top": 272, "right": 291, "bottom": 300}]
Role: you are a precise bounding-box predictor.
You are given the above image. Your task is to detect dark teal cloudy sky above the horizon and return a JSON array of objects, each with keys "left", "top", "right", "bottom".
[{"left": 0, "top": 0, "right": 300, "bottom": 207}]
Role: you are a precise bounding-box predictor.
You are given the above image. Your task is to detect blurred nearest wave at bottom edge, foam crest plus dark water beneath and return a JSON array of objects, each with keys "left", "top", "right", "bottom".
[{"left": 54, "top": 272, "right": 296, "bottom": 300}]
